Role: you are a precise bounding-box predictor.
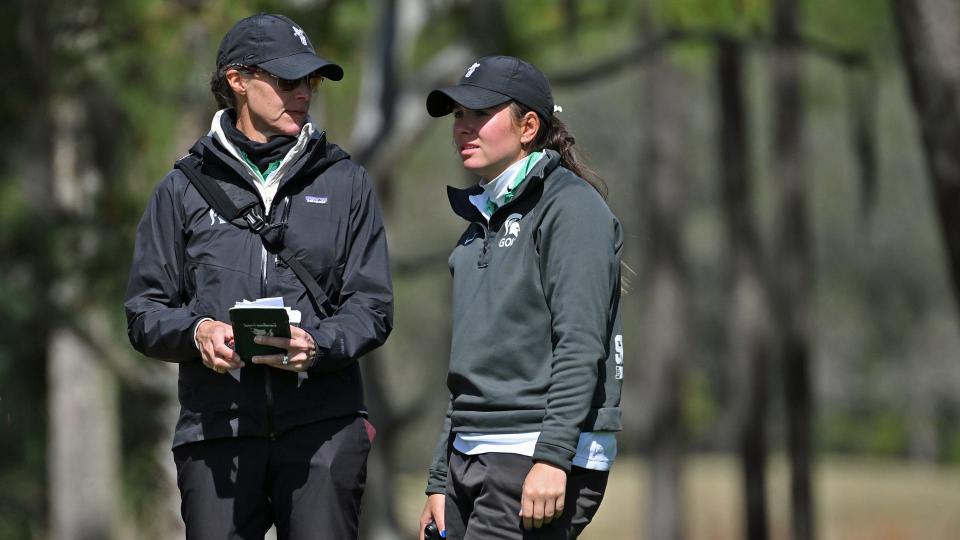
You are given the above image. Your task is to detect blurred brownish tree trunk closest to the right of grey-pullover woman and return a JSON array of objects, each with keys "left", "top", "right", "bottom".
[{"left": 638, "top": 53, "right": 689, "bottom": 540}]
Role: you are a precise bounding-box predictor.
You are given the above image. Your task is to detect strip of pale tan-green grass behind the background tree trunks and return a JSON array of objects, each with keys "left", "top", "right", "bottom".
[{"left": 397, "top": 455, "right": 960, "bottom": 540}]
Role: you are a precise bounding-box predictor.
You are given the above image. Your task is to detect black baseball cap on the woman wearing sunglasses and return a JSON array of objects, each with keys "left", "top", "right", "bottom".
[{"left": 217, "top": 13, "right": 343, "bottom": 81}]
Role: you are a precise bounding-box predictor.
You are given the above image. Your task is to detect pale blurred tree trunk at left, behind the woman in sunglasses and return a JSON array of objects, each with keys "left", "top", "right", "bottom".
[{"left": 47, "top": 96, "right": 120, "bottom": 540}]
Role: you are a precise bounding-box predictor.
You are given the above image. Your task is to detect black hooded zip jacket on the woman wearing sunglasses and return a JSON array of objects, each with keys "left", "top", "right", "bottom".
[{"left": 125, "top": 122, "right": 393, "bottom": 446}]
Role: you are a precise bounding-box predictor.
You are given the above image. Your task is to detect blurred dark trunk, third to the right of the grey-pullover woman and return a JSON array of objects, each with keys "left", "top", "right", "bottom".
[{"left": 770, "top": 0, "right": 814, "bottom": 540}]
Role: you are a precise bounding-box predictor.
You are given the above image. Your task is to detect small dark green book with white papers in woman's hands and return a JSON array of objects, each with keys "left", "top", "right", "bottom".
[{"left": 230, "top": 297, "right": 300, "bottom": 360}]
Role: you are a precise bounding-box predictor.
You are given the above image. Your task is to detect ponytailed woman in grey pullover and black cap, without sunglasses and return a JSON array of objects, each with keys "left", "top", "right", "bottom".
[{"left": 420, "top": 56, "right": 623, "bottom": 539}]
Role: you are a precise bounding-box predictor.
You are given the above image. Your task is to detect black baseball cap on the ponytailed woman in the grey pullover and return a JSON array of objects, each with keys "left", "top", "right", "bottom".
[{"left": 427, "top": 56, "right": 553, "bottom": 120}]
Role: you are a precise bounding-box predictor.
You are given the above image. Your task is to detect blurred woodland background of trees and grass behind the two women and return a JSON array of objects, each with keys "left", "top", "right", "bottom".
[{"left": 0, "top": 0, "right": 960, "bottom": 540}]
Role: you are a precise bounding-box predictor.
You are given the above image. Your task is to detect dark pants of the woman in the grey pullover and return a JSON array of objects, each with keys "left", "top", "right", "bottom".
[{"left": 443, "top": 450, "right": 608, "bottom": 540}]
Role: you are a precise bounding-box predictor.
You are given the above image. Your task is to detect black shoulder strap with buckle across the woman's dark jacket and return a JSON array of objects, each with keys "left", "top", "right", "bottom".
[{"left": 174, "top": 152, "right": 334, "bottom": 317}]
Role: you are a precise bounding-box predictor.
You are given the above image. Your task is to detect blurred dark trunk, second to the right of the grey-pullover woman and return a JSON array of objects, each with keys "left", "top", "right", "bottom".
[{"left": 716, "top": 38, "right": 771, "bottom": 540}]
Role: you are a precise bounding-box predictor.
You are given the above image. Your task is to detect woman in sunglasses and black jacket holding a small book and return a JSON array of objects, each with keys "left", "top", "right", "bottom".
[{"left": 126, "top": 14, "right": 392, "bottom": 539}]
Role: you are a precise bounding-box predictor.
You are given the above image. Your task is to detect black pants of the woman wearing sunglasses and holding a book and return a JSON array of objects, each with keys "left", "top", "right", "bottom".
[{"left": 173, "top": 417, "right": 370, "bottom": 540}]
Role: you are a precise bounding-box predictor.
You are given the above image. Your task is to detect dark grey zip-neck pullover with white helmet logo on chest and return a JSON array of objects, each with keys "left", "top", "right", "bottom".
[{"left": 426, "top": 150, "right": 623, "bottom": 494}]
